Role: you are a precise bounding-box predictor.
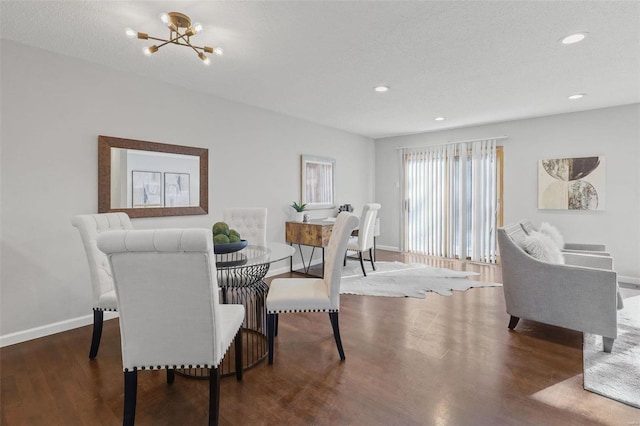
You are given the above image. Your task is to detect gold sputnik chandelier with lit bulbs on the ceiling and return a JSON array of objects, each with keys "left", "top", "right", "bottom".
[{"left": 126, "top": 12, "right": 223, "bottom": 65}]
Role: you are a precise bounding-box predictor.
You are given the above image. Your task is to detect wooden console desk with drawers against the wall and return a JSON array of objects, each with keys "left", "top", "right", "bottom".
[{"left": 285, "top": 219, "right": 335, "bottom": 274}]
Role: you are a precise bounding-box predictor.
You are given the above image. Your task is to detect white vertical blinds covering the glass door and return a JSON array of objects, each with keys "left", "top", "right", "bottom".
[{"left": 402, "top": 139, "right": 499, "bottom": 263}]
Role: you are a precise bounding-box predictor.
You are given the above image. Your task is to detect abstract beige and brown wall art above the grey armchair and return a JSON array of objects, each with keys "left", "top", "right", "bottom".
[{"left": 538, "top": 157, "right": 606, "bottom": 210}]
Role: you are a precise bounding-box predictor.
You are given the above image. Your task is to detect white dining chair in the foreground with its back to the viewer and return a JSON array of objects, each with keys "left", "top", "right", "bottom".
[{"left": 98, "top": 229, "right": 244, "bottom": 425}]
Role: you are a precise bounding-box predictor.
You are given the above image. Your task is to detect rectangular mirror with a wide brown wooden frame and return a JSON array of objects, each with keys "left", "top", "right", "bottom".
[{"left": 98, "top": 135, "right": 209, "bottom": 218}]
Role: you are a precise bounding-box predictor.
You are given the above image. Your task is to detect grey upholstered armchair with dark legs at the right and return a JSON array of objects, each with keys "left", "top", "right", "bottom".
[{"left": 498, "top": 224, "right": 618, "bottom": 352}]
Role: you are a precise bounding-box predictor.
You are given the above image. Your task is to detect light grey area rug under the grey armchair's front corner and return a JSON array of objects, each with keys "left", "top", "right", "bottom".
[{"left": 583, "top": 296, "right": 640, "bottom": 408}]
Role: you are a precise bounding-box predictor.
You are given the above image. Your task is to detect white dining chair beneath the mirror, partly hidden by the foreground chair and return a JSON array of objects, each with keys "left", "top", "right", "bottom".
[{"left": 71, "top": 213, "right": 133, "bottom": 359}]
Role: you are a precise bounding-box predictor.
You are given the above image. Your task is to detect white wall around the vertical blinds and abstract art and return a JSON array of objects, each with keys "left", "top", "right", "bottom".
[{"left": 376, "top": 104, "right": 640, "bottom": 283}]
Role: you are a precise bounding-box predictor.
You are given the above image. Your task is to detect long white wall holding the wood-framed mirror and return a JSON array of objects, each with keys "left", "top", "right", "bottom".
[{"left": 0, "top": 40, "right": 374, "bottom": 344}]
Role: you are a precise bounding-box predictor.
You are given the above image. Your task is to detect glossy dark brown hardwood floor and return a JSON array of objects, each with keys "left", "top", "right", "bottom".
[{"left": 0, "top": 251, "right": 640, "bottom": 426}]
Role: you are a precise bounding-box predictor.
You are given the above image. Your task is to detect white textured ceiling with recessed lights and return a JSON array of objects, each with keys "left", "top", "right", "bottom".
[{"left": 0, "top": 0, "right": 640, "bottom": 138}]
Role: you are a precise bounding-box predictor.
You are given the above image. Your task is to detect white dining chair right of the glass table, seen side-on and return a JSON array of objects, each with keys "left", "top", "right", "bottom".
[{"left": 267, "top": 212, "right": 358, "bottom": 364}]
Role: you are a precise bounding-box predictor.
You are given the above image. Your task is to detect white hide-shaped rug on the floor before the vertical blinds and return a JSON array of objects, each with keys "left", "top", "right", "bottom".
[{"left": 340, "top": 260, "right": 502, "bottom": 299}]
